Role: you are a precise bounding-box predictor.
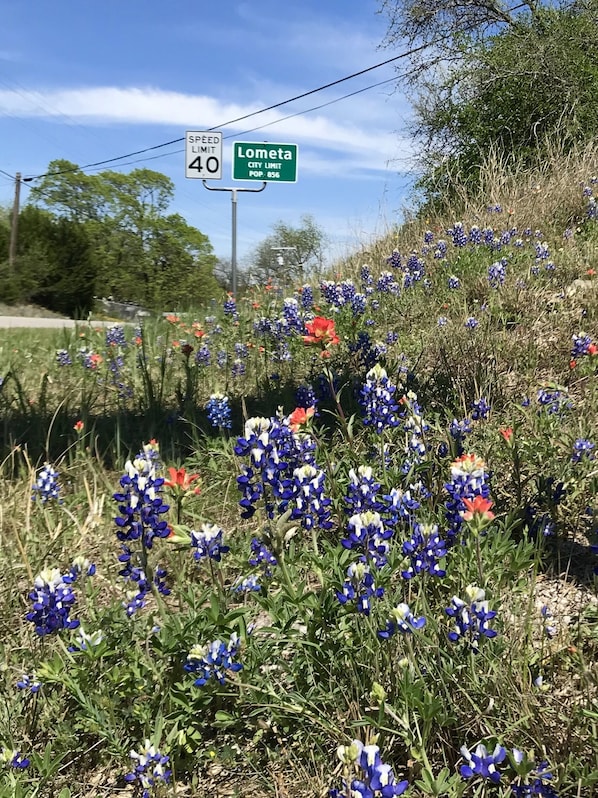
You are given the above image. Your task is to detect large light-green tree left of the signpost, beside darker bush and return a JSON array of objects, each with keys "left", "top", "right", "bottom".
[{"left": 30, "top": 161, "right": 223, "bottom": 309}]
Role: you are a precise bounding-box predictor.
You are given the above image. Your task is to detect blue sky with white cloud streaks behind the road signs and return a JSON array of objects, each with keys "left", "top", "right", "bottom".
[{"left": 0, "top": 0, "right": 420, "bottom": 262}]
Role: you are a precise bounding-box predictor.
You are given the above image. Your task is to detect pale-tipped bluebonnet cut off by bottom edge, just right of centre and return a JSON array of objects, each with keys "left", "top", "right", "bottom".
[{"left": 328, "top": 740, "right": 409, "bottom": 798}]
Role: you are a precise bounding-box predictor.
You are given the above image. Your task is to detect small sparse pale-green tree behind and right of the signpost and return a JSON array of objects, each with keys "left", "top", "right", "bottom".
[{"left": 248, "top": 215, "right": 325, "bottom": 285}]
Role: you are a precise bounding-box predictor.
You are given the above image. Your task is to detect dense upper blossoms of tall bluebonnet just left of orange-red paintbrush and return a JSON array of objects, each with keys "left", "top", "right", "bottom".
[{"left": 113, "top": 449, "right": 170, "bottom": 549}]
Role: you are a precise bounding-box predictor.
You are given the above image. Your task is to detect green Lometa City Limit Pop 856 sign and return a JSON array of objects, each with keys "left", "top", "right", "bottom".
[{"left": 233, "top": 141, "right": 297, "bottom": 183}]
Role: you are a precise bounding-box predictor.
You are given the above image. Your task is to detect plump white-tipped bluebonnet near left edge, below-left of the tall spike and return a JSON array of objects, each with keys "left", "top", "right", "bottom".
[{"left": 25, "top": 568, "right": 79, "bottom": 637}]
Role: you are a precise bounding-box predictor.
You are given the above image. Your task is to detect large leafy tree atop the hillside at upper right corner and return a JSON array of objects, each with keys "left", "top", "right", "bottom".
[{"left": 384, "top": 0, "right": 598, "bottom": 209}]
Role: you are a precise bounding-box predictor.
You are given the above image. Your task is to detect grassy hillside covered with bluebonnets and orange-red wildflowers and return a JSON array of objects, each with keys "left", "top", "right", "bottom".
[{"left": 0, "top": 148, "right": 598, "bottom": 798}]
